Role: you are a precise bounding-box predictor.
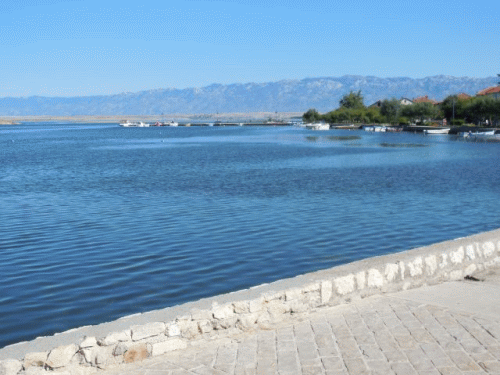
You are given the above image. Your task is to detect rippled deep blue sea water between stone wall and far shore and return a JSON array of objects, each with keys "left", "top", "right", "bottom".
[{"left": 0, "top": 123, "right": 500, "bottom": 347}]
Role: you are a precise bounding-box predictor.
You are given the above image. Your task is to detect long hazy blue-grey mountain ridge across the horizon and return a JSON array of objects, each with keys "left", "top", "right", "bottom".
[{"left": 0, "top": 75, "right": 498, "bottom": 116}]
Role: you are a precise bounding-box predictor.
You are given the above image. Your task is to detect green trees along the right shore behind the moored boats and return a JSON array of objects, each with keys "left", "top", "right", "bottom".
[{"left": 302, "top": 81, "right": 500, "bottom": 126}]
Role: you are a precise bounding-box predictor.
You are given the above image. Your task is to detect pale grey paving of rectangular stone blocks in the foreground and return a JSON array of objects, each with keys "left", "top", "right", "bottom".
[{"left": 103, "top": 296, "right": 500, "bottom": 375}]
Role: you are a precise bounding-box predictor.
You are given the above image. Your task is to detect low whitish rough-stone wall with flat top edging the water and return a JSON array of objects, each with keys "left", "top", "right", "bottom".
[{"left": 0, "top": 230, "right": 500, "bottom": 375}]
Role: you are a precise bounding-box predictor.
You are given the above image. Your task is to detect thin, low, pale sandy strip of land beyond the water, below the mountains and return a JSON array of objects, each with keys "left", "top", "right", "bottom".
[{"left": 0, "top": 112, "right": 303, "bottom": 125}]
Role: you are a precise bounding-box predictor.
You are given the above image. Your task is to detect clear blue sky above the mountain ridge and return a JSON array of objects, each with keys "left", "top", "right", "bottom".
[{"left": 0, "top": 0, "right": 500, "bottom": 97}]
